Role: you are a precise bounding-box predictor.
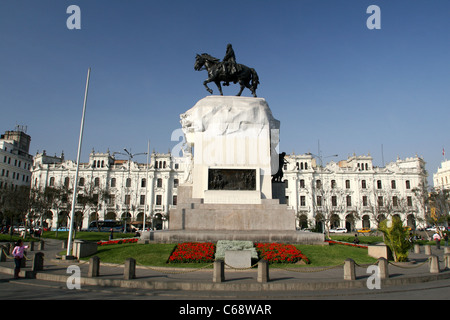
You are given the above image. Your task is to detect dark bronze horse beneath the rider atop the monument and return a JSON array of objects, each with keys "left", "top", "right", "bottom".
[{"left": 194, "top": 53, "right": 259, "bottom": 98}]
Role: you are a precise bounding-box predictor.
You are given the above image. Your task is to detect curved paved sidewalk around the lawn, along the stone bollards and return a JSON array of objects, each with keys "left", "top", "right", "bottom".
[{"left": 0, "top": 239, "right": 450, "bottom": 291}]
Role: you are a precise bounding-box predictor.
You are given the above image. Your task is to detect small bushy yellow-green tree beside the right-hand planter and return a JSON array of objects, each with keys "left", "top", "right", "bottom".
[{"left": 378, "top": 216, "right": 411, "bottom": 262}]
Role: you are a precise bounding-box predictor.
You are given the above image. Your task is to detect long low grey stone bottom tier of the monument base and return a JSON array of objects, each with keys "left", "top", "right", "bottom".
[{"left": 140, "top": 230, "right": 328, "bottom": 245}]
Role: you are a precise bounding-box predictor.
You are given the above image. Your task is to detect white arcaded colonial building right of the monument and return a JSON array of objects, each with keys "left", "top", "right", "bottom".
[{"left": 283, "top": 154, "right": 427, "bottom": 231}]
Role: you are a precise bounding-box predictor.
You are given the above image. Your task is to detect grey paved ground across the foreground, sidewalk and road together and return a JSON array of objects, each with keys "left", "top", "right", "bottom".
[{"left": 0, "top": 240, "right": 450, "bottom": 299}]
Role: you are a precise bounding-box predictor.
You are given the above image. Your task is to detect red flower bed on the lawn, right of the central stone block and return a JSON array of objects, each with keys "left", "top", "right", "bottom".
[{"left": 255, "top": 243, "right": 309, "bottom": 263}]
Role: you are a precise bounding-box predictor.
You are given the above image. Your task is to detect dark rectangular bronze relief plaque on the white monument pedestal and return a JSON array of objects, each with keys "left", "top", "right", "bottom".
[{"left": 208, "top": 169, "right": 256, "bottom": 190}]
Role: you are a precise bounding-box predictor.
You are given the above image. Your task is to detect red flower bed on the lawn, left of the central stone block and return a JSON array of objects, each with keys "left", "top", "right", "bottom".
[{"left": 169, "top": 242, "right": 215, "bottom": 263}]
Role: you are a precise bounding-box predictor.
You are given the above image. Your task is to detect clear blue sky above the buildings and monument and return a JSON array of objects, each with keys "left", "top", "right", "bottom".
[{"left": 0, "top": 0, "right": 450, "bottom": 185}]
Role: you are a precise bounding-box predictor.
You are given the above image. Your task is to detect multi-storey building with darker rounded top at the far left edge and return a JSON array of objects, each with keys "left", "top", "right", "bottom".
[{"left": 0, "top": 126, "right": 33, "bottom": 189}]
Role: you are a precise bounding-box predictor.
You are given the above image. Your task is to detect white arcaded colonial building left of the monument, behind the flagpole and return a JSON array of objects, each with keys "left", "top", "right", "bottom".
[{"left": 32, "top": 151, "right": 186, "bottom": 229}]
